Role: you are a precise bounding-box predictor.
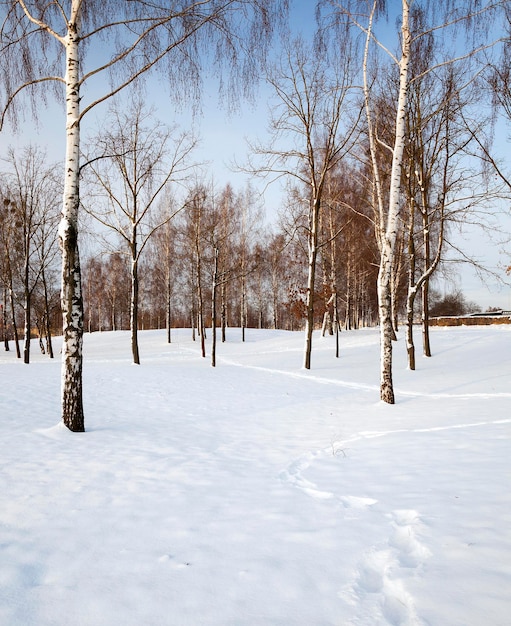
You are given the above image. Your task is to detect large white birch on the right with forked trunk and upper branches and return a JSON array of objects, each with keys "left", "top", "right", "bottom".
[{"left": 319, "top": 0, "right": 503, "bottom": 404}]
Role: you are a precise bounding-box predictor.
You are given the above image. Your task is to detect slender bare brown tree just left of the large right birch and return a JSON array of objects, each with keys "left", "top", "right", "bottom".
[{"left": 253, "top": 33, "right": 356, "bottom": 369}]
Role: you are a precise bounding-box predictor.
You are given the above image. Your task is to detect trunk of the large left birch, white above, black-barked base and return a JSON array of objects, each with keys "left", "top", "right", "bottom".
[{"left": 59, "top": 7, "right": 85, "bottom": 432}]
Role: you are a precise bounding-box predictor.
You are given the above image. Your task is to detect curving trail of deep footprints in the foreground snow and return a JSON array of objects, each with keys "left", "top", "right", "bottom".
[{"left": 279, "top": 419, "right": 511, "bottom": 626}]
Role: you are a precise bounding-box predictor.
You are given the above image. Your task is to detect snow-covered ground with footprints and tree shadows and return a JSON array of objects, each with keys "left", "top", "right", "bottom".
[{"left": 0, "top": 326, "right": 511, "bottom": 626}]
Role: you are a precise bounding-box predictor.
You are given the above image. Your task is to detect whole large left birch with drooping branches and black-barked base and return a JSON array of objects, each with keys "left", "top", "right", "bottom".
[{"left": 0, "top": 0, "right": 287, "bottom": 432}]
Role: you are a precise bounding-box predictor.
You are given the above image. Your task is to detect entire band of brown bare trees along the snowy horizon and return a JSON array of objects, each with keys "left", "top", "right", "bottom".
[{"left": 0, "top": 134, "right": 492, "bottom": 362}]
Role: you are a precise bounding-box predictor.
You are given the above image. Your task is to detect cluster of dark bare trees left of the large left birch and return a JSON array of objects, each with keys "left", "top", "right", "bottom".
[{"left": 0, "top": 148, "right": 62, "bottom": 363}]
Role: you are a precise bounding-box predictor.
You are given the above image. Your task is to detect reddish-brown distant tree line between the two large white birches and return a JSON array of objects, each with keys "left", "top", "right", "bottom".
[{"left": 84, "top": 168, "right": 384, "bottom": 337}]
